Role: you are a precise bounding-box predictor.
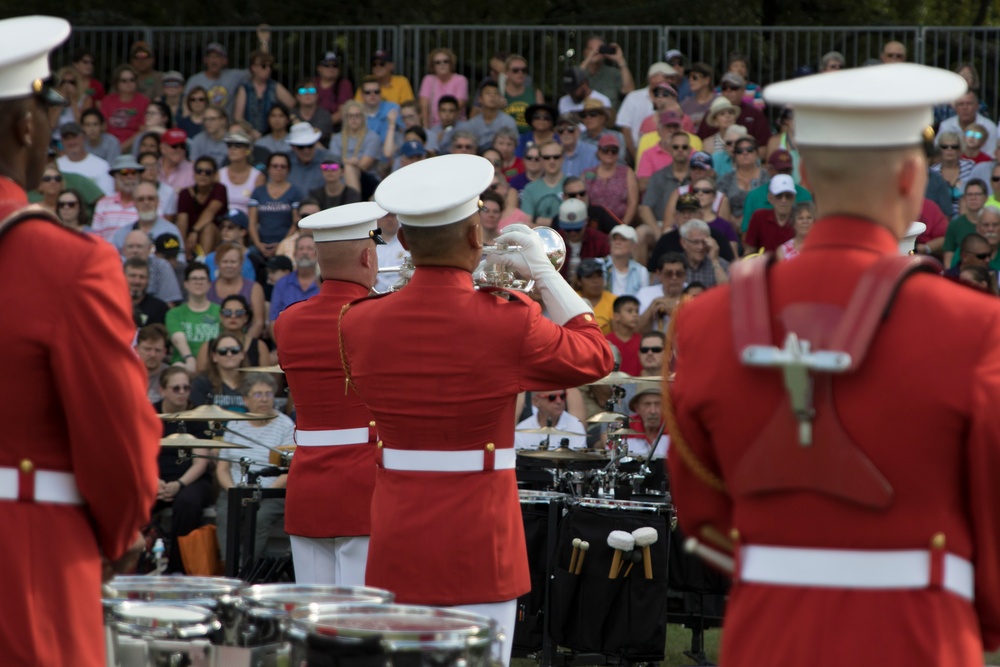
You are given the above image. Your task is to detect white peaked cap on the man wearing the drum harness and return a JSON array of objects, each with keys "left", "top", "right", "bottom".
[{"left": 764, "top": 63, "right": 969, "bottom": 148}]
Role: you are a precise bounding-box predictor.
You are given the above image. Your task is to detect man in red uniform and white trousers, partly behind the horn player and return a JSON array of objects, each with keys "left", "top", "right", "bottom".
[{"left": 274, "top": 202, "right": 385, "bottom": 586}]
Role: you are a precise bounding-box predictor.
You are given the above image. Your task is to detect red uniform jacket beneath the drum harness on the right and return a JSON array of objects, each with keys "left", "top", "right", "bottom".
[{"left": 668, "top": 218, "right": 1000, "bottom": 667}]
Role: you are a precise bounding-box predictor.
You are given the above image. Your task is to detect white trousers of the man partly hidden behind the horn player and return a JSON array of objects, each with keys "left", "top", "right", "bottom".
[{"left": 289, "top": 535, "right": 368, "bottom": 586}]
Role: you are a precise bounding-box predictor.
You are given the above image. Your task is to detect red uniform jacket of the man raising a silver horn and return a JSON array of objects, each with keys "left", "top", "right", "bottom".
[{"left": 342, "top": 267, "right": 613, "bottom": 605}]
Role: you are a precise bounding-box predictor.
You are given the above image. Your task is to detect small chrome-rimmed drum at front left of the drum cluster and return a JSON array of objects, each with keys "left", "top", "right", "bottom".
[{"left": 109, "top": 601, "right": 222, "bottom": 667}]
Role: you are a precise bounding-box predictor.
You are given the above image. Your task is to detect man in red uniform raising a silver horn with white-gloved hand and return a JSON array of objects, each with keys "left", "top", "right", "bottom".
[{"left": 341, "top": 155, "right": 613, "bottom": 664}]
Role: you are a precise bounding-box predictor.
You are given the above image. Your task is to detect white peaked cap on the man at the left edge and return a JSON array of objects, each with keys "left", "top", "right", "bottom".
[{"left": 0, "top": 16, "right": 69, "bottom": 100}]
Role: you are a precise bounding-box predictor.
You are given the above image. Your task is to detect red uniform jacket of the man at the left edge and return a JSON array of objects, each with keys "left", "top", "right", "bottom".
[{"left": 0, "top": 179, "right": 162, "bottom": 667}]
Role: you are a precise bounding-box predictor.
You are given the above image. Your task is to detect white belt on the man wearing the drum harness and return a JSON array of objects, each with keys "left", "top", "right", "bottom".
[{"left": 739, "top": 545, "right": 974, "bottom": 600}]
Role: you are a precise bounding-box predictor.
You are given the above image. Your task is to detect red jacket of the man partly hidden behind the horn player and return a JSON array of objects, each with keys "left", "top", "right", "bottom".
[{"left": 274, "top": 280, "right": 375, "bottom": 537}]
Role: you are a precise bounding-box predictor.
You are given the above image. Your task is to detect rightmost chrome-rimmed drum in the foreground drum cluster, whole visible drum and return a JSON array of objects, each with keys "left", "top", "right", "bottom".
[{"left": 288, "top": 604, "right": 499, "bottom": 667}]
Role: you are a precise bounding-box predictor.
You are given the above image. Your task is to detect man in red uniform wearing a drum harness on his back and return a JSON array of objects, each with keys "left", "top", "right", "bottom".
[{"left": 668, "top": 65, "right": 1000, "bottom": 667}]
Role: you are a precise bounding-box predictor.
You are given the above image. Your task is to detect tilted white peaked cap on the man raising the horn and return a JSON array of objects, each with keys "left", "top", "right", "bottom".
[{"left": 375, "top": 155, "right": 496, "bottom": 227}]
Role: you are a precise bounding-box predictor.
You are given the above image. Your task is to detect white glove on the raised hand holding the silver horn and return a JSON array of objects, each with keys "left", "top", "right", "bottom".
[{"left": 486, "top": 230, "right": 594, "bottom": 326}]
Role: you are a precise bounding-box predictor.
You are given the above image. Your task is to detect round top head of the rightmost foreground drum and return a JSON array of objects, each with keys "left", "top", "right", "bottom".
[{"left": 292, "top": 605, "right": 497, "bottom": 653}]
